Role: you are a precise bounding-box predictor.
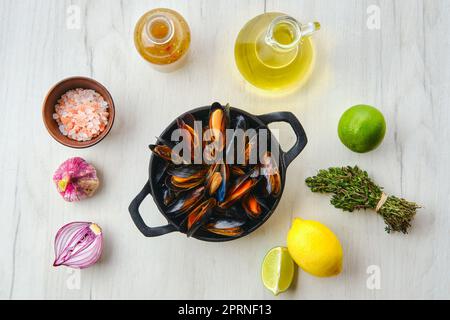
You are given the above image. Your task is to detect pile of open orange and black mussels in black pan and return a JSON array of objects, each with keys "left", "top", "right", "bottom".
[{"left": 150, "top": 103, "right": 281, "bottom": 237}]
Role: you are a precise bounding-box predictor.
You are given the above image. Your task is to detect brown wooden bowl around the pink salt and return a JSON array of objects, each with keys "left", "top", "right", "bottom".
[{"left": 42, "top": 77, "right": 115, "bottom": 149}]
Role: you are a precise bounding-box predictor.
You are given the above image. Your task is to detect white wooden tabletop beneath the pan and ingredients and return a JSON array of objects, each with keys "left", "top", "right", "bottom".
[{"left": 0, "top": 0, "right": 450, "bottom": 299}]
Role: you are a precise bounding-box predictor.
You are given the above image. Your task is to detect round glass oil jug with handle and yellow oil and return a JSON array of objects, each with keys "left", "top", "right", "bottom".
[{"left": 235, "top": 12, "right": 320, "bottom": 92}]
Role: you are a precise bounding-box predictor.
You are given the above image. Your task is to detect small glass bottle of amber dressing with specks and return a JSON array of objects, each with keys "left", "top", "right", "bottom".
[{"left": 134, "top": 8, "right": 191, "bottom": 71}]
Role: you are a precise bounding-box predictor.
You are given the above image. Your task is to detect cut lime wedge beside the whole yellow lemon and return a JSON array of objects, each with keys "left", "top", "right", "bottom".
[{"left": 261, "top": 247, "right": 294, "bottom": 295}]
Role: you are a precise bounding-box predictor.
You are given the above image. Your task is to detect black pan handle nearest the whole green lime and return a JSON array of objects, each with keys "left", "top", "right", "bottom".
[{"left": 258, "top": 112, "right": 308, "bottom": 168}]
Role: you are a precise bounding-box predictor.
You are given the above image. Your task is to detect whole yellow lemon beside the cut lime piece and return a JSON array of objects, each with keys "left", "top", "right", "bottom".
[{"left": 287, "top": 219, "right": 343, "bottom": 277}]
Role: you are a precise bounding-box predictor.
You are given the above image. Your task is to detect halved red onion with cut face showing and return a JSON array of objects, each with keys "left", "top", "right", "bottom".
[{"left": 53, "top": 222, "right": 103, "bottom": 269}]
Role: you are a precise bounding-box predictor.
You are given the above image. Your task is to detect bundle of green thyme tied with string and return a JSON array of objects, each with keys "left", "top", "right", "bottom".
[{"left": 306, "top": 166, "right": 420, "bottom": 234}]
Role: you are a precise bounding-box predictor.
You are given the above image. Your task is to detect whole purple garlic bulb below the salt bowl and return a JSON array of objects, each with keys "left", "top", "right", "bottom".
[{"left": 53, "top": 157, "right": 99, "bottom": 202}]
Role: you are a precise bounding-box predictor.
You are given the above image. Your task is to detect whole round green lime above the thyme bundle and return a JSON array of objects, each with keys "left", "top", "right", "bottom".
[{"left": 338, "top": 105, "right": 386, "bottom": 153}]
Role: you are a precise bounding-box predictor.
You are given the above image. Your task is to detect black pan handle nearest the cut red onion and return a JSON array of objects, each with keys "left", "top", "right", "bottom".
[{"left": 128, "top": 182, "right": 177, "bottom": 237}]
